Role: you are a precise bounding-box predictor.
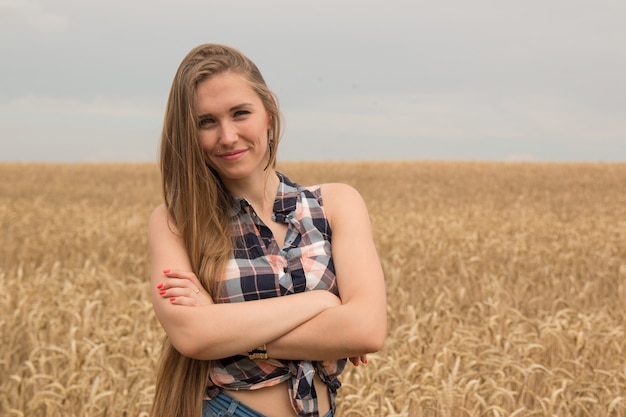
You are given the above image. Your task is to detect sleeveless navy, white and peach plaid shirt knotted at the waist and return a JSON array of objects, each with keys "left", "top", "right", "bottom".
[{"left": 208, "top": 173, "right": 346, "bottom": 417}]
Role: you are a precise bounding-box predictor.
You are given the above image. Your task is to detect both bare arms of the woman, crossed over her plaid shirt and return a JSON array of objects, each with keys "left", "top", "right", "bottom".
[{"left": 149, "top": 184, "right": 387, "bottom": 362}]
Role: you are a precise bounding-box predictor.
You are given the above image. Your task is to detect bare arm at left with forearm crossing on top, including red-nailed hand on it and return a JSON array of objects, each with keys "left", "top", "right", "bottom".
[{"left": 149, "top": 206, "right": 339, "bottom": 360}]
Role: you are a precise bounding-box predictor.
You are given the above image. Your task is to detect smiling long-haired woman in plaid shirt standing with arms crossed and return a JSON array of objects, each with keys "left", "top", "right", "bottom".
[{"left": 149, "top": 44, "right": 386, "bottom": 417}]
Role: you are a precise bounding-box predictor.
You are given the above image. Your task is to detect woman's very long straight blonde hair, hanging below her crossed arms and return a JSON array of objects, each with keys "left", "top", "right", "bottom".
[{"left": 151, "top": 44, "right": 281, "bottom": 417}]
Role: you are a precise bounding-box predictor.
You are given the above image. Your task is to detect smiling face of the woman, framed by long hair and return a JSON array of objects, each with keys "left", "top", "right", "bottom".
[{"left": 195, "top": 73, "right": 271, "bottom": 182}]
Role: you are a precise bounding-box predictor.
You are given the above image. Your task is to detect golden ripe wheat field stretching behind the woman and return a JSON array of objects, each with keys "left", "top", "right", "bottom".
[{"left": 0, "top": 161, "right": 626, "bottom": 417}]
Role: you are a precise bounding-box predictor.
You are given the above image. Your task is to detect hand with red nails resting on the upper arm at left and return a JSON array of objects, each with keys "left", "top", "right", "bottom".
[{"left": 157, "top": 269, "right": 213, "bottom": 306}]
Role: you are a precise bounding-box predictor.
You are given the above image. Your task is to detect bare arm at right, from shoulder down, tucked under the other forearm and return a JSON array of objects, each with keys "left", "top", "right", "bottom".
[{"left": 268, "top": 184, "right": 387, "bottom": 360}]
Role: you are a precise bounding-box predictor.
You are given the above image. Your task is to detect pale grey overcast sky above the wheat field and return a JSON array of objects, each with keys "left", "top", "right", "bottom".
[{"left": 0, "top": 0, "right": 626, "bottom": 162}]
